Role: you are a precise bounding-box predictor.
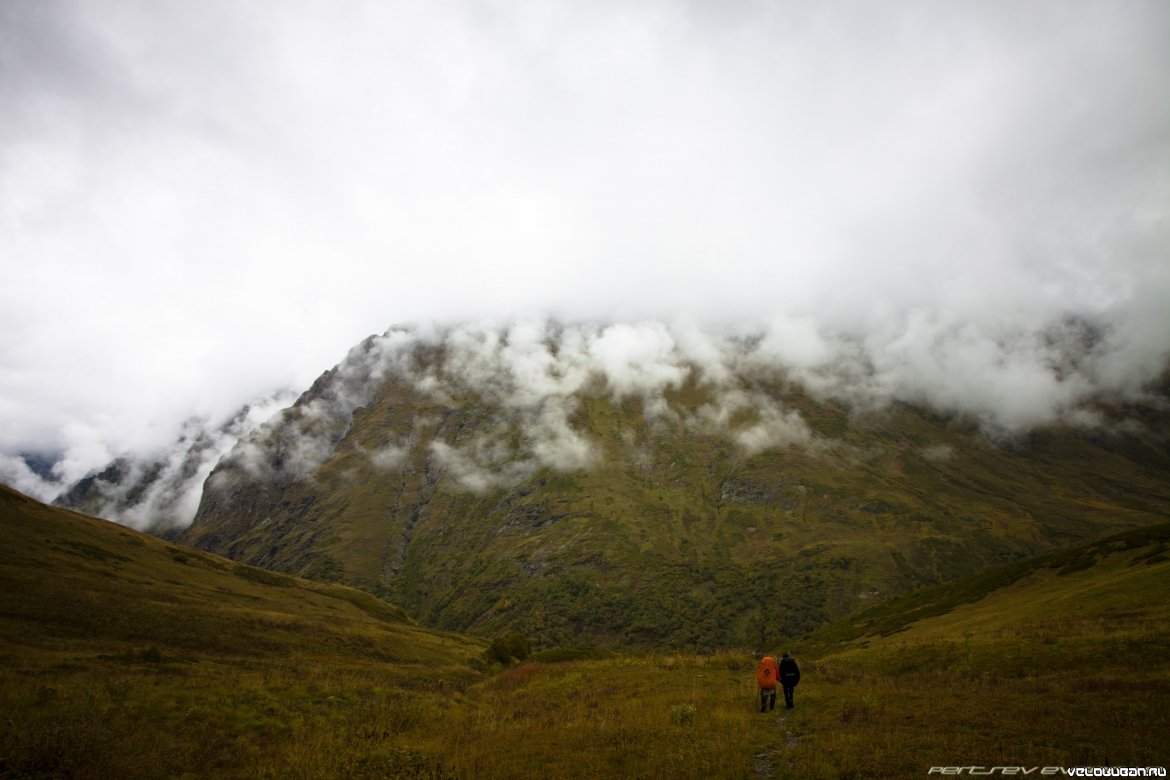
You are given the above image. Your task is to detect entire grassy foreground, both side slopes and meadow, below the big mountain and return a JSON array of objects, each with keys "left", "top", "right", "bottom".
[{"left": 0, "top": 491, "right": 1170, "bottom": 778}]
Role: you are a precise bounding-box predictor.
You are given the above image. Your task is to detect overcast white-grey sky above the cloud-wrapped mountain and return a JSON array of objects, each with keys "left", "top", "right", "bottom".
[{"left": 0, "top": 0, "right": 1170, "bottom": 500}]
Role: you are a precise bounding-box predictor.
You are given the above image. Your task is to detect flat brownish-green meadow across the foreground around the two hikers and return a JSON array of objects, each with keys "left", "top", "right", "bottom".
[{"left": 0, "top": 637, "right": 1170, "bottom": 778}]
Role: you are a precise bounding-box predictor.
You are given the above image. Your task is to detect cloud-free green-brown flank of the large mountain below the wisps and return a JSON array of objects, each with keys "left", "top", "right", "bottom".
[{"left": 185, "top": 369, "right": 1170, "bottom": 649}]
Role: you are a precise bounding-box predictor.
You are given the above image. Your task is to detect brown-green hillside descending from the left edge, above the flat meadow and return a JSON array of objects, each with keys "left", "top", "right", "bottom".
[{"left": 0, "top": 486, "right": 482, "bottom": 668}]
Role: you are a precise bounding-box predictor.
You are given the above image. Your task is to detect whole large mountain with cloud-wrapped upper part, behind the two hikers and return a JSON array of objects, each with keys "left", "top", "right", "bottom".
[{"left": 173, "top": 325, "right": 1170, "bottom": 649}]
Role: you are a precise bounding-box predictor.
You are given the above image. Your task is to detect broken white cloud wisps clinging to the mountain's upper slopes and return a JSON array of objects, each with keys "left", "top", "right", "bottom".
[{"left": 213, "top": 319, "right": 1151, "bottom": 512}]
